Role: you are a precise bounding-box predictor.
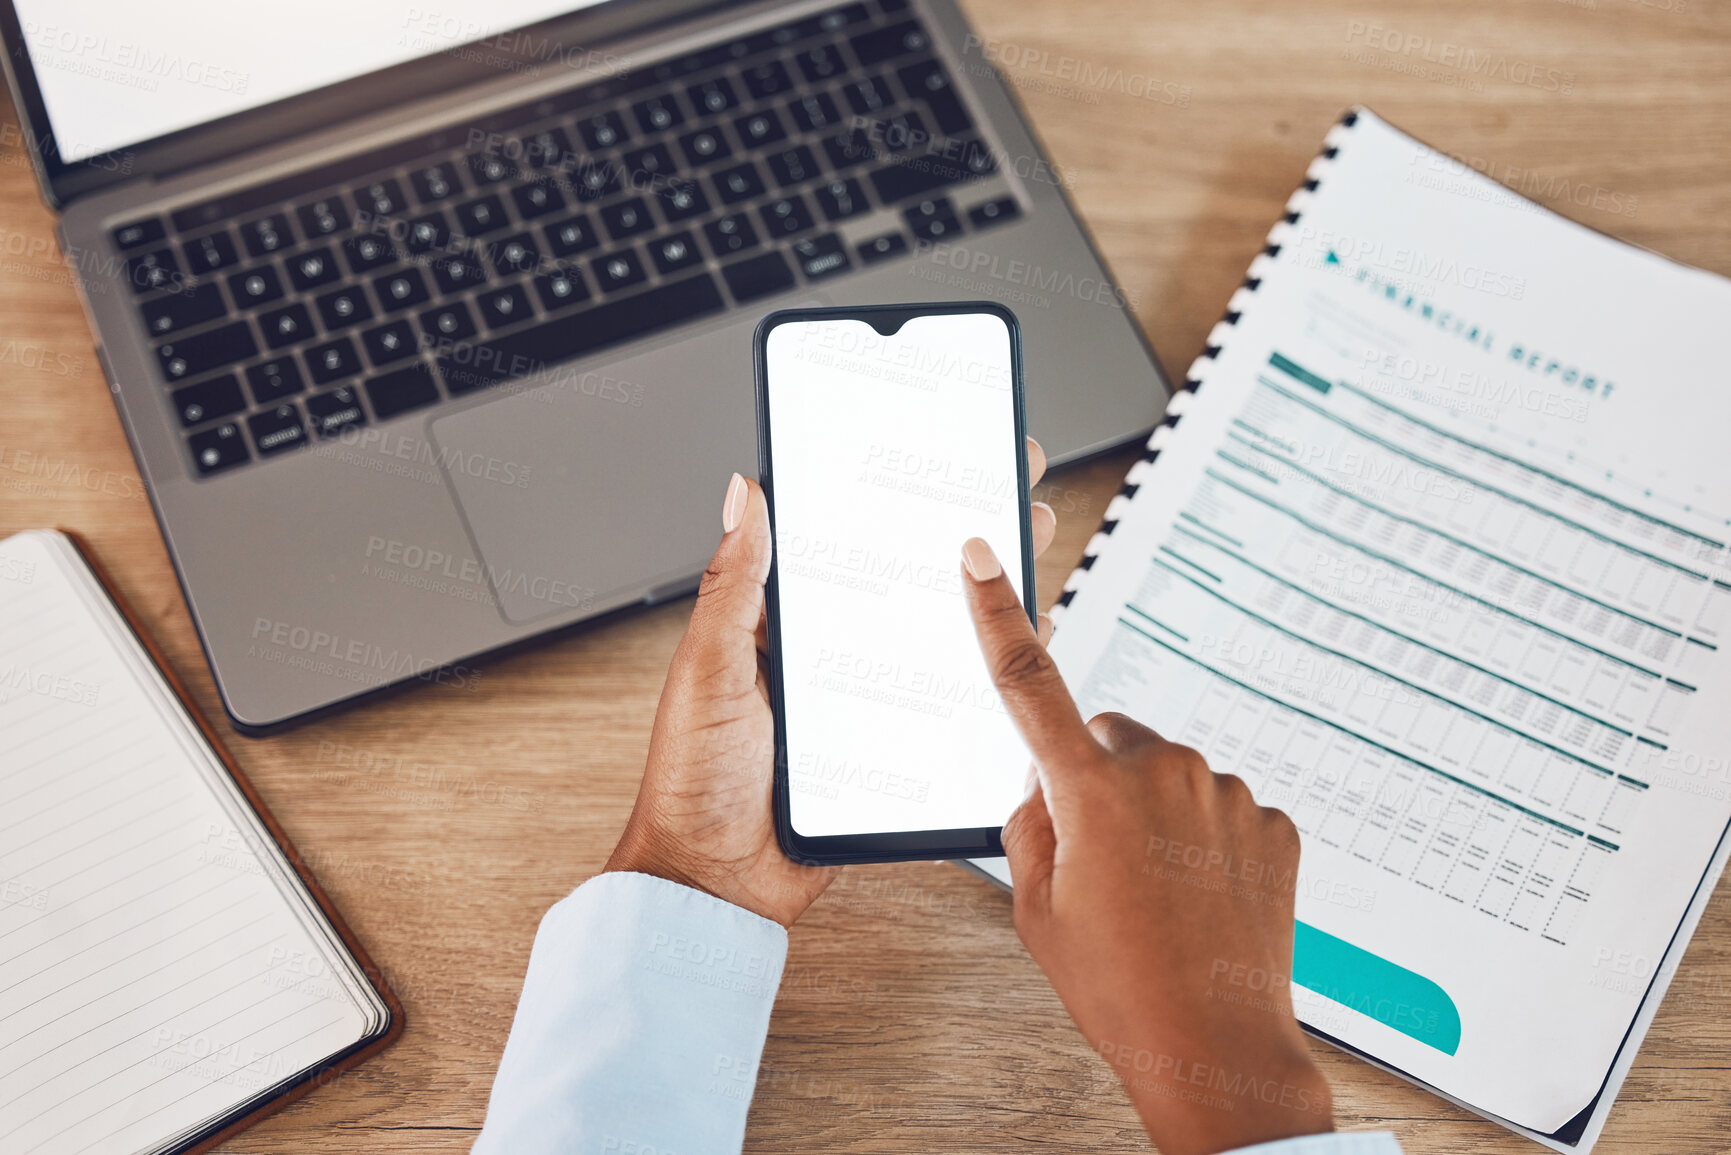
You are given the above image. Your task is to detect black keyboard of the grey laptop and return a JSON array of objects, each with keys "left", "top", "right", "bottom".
[{"left": 113, "top": 0, "right": 1018, "bottom": 474}]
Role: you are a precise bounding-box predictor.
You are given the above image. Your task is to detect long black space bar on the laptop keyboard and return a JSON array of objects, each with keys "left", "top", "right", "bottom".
[{"left": 438, "top": 274, "right": 724, "bottom": 393}]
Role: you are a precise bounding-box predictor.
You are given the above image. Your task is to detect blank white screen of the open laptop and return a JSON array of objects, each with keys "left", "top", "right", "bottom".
[{"left": 14, "top": 0, "right": 616, "bottom": 161}]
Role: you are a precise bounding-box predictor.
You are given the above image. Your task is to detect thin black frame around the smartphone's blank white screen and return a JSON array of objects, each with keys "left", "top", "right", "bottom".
[{"left": 751, "top": 301, "right": 1039, "bottom": 866}]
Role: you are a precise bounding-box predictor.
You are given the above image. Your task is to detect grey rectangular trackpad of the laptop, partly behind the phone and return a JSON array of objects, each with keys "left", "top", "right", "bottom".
[{"left": 428, "top": 322, "right": 756, "bottom": 625}]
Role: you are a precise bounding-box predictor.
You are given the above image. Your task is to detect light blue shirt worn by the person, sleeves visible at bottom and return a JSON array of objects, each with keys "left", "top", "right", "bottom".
[{"left": 473, "top": 873, "right": 1400, "bottom": 1155}]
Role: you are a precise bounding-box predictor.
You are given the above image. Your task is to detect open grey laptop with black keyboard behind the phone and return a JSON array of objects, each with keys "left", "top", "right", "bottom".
[{"left": 0, "top": 0, "right": 1167, "bottom": 734}]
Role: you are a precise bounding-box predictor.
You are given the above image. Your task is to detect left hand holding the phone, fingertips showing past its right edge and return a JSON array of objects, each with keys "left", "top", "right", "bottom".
[{"left": 606, "top": 438, "right": 1058, "bottom": 926}]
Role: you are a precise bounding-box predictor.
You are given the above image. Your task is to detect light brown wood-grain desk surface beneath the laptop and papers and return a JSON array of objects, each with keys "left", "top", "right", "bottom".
[{"left": 0, "top": 0, "right": 1731, "bottom": 1153}]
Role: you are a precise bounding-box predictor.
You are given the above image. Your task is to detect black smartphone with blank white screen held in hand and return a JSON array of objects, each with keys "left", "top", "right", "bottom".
[{"left": 755, "top": 303, "right": 1035, "bottom": 862}]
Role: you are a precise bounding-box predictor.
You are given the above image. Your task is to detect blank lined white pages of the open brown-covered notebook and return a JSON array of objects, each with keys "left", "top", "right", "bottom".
[{"left": 0, "top": 532, "right": 386, "bottom": 1155}]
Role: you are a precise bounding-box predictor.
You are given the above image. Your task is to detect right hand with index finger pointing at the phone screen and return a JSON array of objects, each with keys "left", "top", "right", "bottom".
[{"left": 962, "top": 539, "right": 1333, "bottom": 1155}]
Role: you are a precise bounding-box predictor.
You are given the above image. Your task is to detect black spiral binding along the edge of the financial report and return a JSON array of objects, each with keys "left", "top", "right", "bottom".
[{"left": 1049, "top": 107, "right": 1359, "bottom": 623}]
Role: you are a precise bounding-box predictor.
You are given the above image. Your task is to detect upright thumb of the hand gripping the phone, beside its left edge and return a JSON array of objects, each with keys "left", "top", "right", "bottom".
[{"left": 682, "top": 473, "right": 774, "bottom": 681}]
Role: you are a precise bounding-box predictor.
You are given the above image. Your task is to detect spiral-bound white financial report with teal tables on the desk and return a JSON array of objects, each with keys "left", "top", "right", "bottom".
[{"left": 980, "top": 109, "right": 1731, "bottom": 1152}]
